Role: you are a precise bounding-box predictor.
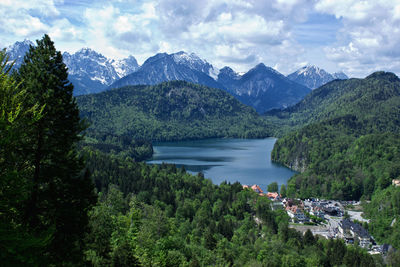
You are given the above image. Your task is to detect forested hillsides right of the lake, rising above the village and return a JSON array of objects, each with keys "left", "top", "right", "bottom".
[{"left": 270, "top": 72, "right": 400, "bottom": 199}]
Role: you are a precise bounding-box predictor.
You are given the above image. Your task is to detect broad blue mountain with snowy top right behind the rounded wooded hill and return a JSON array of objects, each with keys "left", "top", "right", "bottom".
[{"left": 110, "top": 52, "right": 223, "bottom": 89}]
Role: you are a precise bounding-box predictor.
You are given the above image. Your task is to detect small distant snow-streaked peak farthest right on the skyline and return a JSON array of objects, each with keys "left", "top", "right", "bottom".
[{"left": 287, "top": 65, "right": 348, "bottom": 90}]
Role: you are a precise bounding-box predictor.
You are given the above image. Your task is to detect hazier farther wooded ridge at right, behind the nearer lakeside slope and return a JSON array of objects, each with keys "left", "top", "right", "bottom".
[{"left": 265, "top": 71, "right": 400, "bottom": 136}]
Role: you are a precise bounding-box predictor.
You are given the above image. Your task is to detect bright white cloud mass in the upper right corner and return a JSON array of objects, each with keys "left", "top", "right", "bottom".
[{"left": 315, "top": 0, "right": 400, "bottom": 77}]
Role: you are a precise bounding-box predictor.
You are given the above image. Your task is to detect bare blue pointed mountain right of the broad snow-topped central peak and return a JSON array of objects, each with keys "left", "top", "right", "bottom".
[{"left": 218, "top": 63, "right": 311, "bottom": 113}]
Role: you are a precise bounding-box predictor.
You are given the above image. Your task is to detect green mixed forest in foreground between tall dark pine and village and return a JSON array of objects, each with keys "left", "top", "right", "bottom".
[{"left": 79, "top": 149, "right": 383, "bottom": 267}]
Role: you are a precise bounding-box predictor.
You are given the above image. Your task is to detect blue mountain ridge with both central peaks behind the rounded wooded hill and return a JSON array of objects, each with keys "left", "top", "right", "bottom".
[{"left": 110, "top": 52, "right": 310, "bottom": 113}]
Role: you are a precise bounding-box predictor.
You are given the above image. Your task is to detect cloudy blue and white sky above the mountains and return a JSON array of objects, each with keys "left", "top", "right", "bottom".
[{"left": 0, "top": 0, "right": 400, "bottom": 77}]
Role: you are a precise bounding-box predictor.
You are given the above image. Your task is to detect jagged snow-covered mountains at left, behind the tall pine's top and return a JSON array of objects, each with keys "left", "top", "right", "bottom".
[{"left": 3, "top": 40, "right": 139, "bottom": 95}]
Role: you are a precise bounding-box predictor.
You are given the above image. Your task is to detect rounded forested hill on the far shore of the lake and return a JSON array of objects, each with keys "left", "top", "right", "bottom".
[{"left": 77, "top": 81, "right": 269, "bottom": 141}]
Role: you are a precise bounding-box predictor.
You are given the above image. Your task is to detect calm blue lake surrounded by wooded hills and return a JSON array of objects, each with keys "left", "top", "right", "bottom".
[{"left": 147, "top": 138, "right": 296, "bottom": 193}]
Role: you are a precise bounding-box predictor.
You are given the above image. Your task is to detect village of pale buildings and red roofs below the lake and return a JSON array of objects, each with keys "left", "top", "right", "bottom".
[{"left": 243, "top": 184, "right": 391, "bottom": 254}]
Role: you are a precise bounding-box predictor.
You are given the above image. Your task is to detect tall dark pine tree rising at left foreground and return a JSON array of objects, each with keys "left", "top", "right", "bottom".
[{"left": 17, "top": 35, "right": 96, "bottom": 264}]
